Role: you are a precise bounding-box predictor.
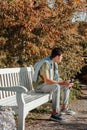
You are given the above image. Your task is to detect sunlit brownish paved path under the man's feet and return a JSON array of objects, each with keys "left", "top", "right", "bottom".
[{"left": 26, "top": 86, "right": 87, "bottom": 130}]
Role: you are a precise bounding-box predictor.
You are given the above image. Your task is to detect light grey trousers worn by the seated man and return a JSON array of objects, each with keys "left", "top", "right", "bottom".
[{"left": 36, "top": 84, "right": 70, "bottom": 111}]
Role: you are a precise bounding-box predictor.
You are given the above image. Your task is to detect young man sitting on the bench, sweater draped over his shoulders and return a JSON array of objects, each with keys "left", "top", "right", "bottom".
[{"left": 34, "top": 47, "right": 75, "bottom": 122}]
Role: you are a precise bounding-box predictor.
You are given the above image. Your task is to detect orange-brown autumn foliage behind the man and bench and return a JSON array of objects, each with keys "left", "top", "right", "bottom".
[{"left": 0, "top": 0, "right": 87, "bottom": 79}]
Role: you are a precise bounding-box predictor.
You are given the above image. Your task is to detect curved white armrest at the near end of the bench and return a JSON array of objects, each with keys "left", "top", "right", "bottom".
[{"left": 0, "top": 86, "right": 28, "bottom": 93}]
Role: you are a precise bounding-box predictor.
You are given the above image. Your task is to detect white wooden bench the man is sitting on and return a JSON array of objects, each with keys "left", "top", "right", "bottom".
[{"left": 0, "top": 67, "right": 51, "bottom": 130}]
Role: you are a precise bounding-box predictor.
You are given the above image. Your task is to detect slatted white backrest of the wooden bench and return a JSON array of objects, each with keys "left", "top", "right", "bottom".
[{"left": 0, "top": 67, "right": 34, "bottom": 98}]
